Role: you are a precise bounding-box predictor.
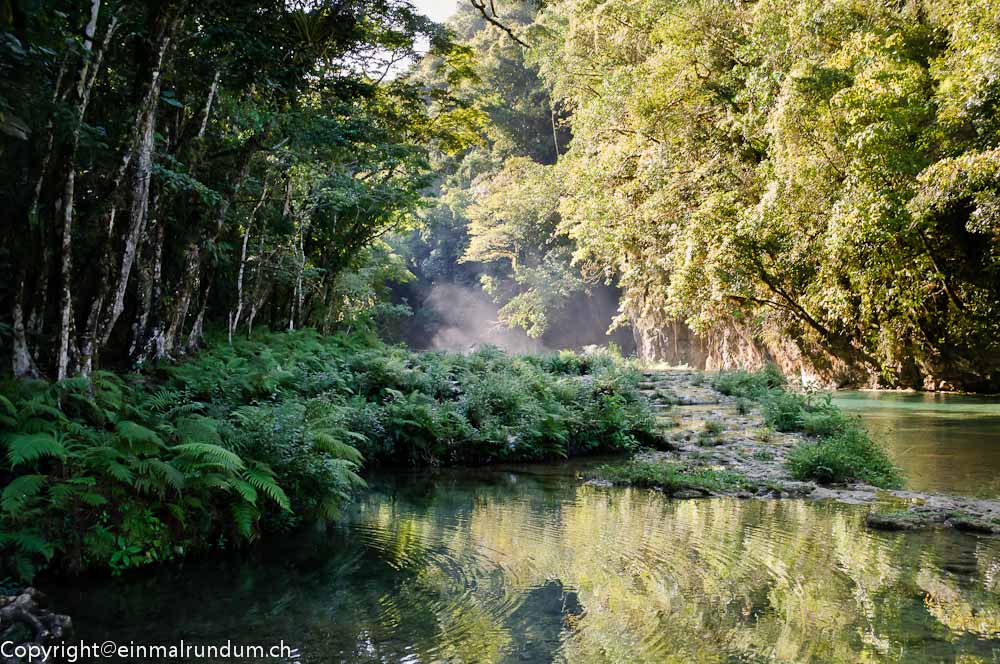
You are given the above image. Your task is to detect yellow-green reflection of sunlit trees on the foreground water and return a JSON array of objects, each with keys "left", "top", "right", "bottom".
[{"left": 350, "top": 476, "right": 1000, "bottom": 662}]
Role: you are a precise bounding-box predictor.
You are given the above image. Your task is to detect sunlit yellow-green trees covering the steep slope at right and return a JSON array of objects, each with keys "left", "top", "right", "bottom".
[{"left": 400, "top": 0, "right": 1000, "bottom": 391}]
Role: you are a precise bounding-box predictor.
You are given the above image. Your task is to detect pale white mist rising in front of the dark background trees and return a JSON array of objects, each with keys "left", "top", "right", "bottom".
[{"left": 425, "top": 284, "right": 547, "bottom": 353}]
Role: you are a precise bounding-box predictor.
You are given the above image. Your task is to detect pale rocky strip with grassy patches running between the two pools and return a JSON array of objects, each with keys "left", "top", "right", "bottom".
[{"left": 589, "top": 370, "right": 1000, "bottom": 534}]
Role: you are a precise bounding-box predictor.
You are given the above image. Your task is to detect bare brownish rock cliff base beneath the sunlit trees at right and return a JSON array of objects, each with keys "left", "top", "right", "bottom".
[{"left": 632, "top": 321, "right": 1000, "bottom": 392}]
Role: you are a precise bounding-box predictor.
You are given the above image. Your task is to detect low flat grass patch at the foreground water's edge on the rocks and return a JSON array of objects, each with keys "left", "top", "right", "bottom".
[{"left": 594, "top": 460, "right": 753, "bottom": 495}]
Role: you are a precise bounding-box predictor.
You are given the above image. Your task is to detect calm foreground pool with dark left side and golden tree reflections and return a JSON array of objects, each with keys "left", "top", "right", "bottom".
[{"left": 60, "top": 472, "right": 1000, "bottom": 662}]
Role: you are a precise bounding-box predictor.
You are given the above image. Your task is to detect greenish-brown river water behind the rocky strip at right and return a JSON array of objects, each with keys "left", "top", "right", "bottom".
[{"left": 834, "top": 392, "right": 1000, "bottom": 497}]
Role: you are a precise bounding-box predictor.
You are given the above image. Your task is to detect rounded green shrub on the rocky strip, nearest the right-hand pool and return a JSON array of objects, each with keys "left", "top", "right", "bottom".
[{"left": 787, "top": 426, "right": 902, "bottom": 488}]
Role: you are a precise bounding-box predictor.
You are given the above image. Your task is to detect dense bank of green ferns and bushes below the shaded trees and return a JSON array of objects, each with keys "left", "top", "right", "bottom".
[{"left": 0, "top": 331, "right": 654, "bottom": 579}]
